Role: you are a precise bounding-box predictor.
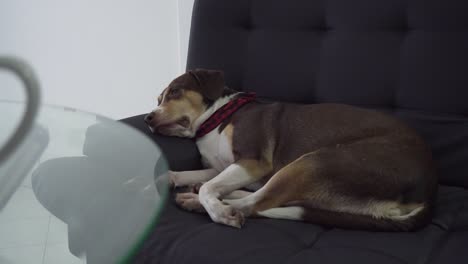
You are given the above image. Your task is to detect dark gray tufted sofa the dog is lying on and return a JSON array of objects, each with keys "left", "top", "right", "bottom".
[{"left": 36, "top": 0, "right": 468, "bottom": 264}]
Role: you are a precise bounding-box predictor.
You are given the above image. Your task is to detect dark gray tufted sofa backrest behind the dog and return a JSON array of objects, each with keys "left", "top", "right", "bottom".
[{"left": 187, "top": 0, "right": 468, "bottom": 187}]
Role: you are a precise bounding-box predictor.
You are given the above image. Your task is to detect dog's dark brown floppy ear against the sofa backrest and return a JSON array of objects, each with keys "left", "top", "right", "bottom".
[{"left": 188, "top": 69, "right": 224, "bottom": 101}]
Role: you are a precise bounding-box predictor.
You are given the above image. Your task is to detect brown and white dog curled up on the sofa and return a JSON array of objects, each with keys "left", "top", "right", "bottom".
[{"left": 145, "top": 69, "right": 437, "bottom": 231}]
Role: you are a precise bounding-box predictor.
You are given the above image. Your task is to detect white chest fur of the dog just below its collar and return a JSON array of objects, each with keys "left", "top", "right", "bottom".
[{"left": 197, "top": 128, "right": 234, "bottom": 172}]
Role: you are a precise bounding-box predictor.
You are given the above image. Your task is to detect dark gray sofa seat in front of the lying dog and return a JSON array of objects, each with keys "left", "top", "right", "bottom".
[{"left": 135, "top": 186, "right": 468, "bottom": 264}]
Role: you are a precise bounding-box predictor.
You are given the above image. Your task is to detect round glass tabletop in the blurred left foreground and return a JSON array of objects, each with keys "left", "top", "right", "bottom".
[{"left": 0, "top": 58, "right": 168, "bottom": 263}]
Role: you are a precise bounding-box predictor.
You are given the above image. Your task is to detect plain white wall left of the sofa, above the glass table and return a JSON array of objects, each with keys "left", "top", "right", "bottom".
[{"left": 0, "top": 0, "right": 181, "bottom": 118}]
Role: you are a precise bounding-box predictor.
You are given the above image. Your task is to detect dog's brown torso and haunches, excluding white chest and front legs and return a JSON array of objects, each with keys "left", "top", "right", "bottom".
[{"left": 225, "top": 103, "right": 436, "bottom": 230}]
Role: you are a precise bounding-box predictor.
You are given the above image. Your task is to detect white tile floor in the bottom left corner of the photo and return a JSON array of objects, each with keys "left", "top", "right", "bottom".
[{"left": 0, "top": 169, "right": 85, "bottom": 264}]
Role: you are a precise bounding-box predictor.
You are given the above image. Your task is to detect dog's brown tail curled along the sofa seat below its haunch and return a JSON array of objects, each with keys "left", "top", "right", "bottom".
[{"left": 300, "top": 204, "right": 432, "bottom": 231}]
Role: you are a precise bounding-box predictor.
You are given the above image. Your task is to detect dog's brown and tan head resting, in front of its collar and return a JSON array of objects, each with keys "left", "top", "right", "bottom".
[{"left": 145, "top": 69, "right": 224, "bottom": 137}]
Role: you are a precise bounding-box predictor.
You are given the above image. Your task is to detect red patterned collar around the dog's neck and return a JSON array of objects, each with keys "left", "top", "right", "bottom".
[{"left": 195, "top": 93, "right": 256, "bottom": 138}]
